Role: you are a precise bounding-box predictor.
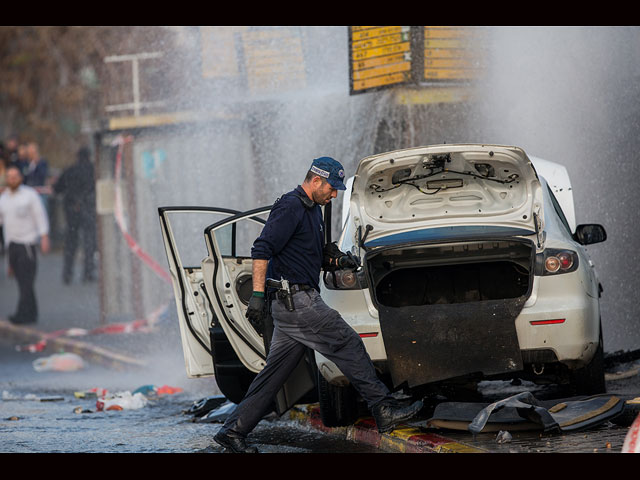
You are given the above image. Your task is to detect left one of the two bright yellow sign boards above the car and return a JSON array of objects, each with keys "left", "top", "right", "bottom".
[{"left": 349, "top": 26, "right": 411, "bottom": 93}]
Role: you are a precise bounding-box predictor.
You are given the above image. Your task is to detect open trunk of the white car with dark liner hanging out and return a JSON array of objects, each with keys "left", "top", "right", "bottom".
[{"left": 365, "top": 238, "right": 535, "bottom": 387}]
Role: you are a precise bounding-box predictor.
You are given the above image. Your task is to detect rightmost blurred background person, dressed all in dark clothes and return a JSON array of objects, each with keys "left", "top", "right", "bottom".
[{"left": 53, "top": 147, "right": 96, "bottom": 285}]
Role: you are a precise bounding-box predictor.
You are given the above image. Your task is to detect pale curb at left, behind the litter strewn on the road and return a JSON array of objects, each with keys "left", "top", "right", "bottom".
[{"left": 0, "top": 319, "right": 146, "bottom": 369}]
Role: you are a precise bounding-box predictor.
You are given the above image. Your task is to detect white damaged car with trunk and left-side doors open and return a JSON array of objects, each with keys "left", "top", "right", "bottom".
[{"left": 159, "top": 144, "right": 606, "bottom": 426}]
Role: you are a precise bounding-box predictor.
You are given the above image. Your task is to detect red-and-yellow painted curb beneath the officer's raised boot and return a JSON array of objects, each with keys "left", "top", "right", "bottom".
[{"left": 289, "top": 404, "right": 489, "bottom": 453}]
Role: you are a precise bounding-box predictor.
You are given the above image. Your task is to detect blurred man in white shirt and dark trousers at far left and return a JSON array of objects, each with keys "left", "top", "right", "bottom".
[{"left": 0, "top": 166, "right": 49, "bottom": 324}]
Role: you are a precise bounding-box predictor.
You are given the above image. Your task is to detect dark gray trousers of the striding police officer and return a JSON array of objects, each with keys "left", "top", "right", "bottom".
[{"left": 223, "top": 290, "right": 390, "bottom": 436}]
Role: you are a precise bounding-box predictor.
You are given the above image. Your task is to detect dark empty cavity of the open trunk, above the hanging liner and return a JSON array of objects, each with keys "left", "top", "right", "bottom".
[{"left": 369, "top": 244, "right": 532, "bottom": 307}]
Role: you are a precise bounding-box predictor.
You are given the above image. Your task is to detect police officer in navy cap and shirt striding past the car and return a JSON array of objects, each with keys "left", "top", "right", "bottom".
[{"left": 214, "top": 157, "right": 422, "bottom": 453}]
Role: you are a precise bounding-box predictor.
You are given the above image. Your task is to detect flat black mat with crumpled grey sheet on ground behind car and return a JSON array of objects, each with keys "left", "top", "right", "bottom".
[{"left": 427, "top": 392, "right": 625, "bottom": 434}]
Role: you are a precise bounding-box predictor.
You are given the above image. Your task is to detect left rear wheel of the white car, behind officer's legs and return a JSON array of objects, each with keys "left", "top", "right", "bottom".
[{"left": 318, "top": 371, "right": 358, "bottom": 427}]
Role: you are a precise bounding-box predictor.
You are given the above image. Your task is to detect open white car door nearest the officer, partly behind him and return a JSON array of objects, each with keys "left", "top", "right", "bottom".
[{"left": 202, "top": 206, "right": 316, "bottom": 414}]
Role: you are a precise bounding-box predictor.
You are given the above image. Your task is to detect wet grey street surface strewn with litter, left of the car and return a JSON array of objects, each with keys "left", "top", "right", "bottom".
[{"left": 0, "top": 252, "right": 384, "bottom": 453}]
